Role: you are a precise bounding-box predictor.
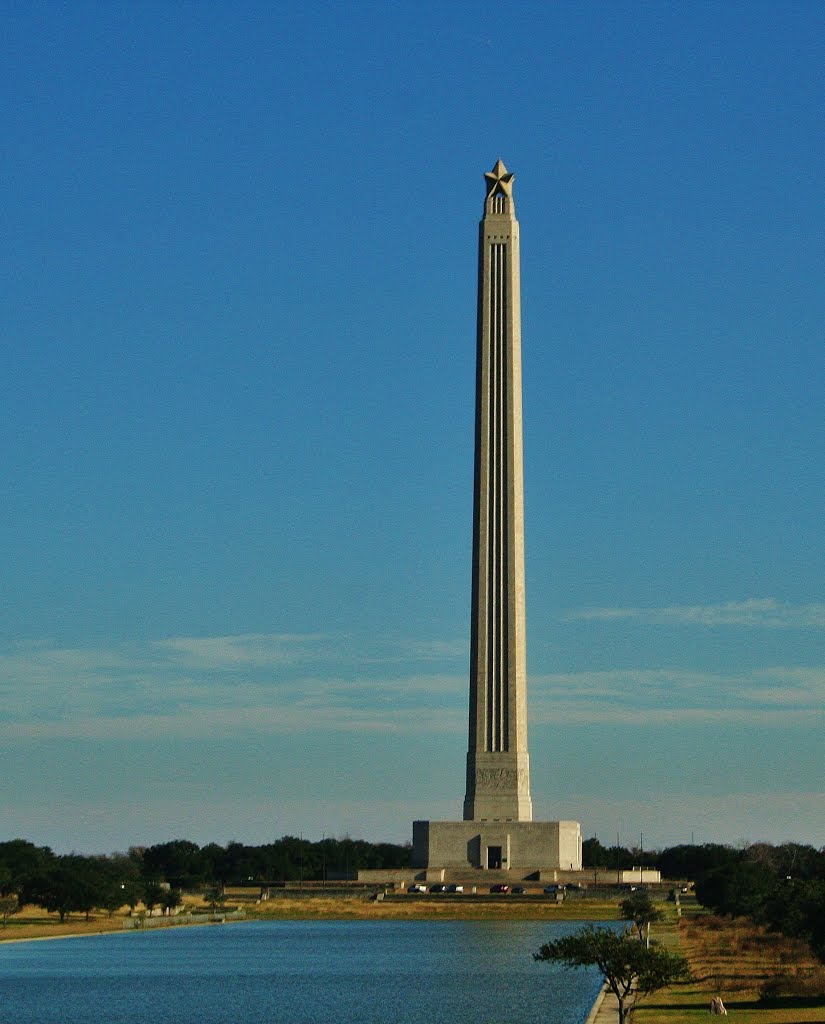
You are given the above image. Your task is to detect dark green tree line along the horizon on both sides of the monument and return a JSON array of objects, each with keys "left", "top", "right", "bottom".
[{"left": 6, "top": 836, "right": 825, "bottom": 961}]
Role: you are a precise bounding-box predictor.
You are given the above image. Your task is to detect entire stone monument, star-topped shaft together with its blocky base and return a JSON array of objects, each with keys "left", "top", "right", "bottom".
[{"left": 413, "top": 160, "right": 581, "bottom": 877}]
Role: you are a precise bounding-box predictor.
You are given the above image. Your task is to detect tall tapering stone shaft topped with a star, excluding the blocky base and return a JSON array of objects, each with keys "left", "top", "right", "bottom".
[{"left": 464, "top": 160, "right": 532, "bottom": 821}]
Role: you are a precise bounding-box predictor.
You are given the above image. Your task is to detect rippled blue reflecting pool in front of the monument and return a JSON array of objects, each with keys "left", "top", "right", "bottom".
[{"left": 0, "top": 921, "right": 601, "bottom": 1024}]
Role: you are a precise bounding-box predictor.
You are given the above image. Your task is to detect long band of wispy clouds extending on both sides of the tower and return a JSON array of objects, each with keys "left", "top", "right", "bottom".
[{"left": 0, "top": 634, "right": 825, "bottom": 739}]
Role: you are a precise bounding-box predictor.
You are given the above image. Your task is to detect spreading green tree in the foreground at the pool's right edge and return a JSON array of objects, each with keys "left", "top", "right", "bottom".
[{"left": 533, "top": 925, "right": 690, "bottom": 1024}]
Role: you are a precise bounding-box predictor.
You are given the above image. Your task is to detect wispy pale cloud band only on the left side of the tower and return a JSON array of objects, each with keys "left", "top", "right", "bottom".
[{"left": 0, "top": 634, "right": 467, "bottom": 739}]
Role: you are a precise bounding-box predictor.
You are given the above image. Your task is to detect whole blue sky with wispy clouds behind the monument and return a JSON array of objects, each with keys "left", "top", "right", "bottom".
[{"left": 0, "top": 2, "right": 825, "bottom": 851}]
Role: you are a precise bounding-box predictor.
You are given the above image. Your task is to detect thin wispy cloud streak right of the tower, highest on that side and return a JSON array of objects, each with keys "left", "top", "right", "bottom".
[{"left": 564, "top": 597, "right": 825, "bottom": 630}]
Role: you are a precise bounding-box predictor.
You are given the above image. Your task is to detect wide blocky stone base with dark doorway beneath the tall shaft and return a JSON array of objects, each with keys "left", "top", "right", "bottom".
[{"left": 413, "top": 821, "right": 581, "bottom": 872}]
